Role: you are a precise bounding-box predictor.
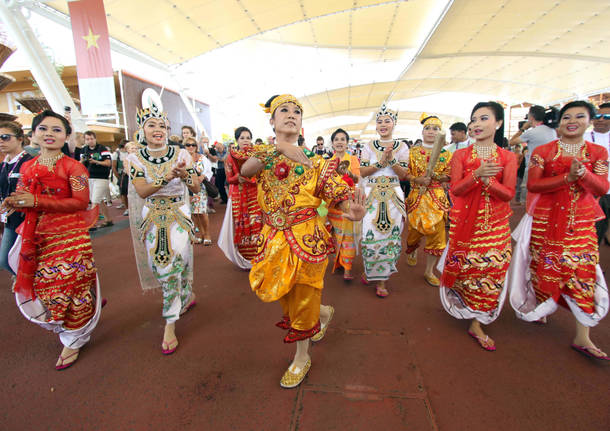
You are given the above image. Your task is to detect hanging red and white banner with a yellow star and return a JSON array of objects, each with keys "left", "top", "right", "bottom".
[{"left": 68, "top": 0, "right": 116, "bottom": 115}]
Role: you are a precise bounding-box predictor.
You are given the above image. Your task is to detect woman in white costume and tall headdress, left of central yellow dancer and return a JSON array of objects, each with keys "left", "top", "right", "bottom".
[{"left": 128, "top": 105, "right": 200, "bottom": 355}]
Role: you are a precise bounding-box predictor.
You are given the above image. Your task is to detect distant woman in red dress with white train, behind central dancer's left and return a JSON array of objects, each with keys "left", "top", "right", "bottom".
[{"left": 218, "top": 127, "right": 263, "bottom": 269}]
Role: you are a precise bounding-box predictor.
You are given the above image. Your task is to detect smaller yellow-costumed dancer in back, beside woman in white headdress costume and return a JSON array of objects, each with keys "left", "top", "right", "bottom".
[{"left": 406, "top": 113, "right": 451, "bottom": 286}]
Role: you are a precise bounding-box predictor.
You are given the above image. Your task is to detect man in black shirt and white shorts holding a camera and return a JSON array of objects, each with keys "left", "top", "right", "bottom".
[{"left": 80, "top": 130, "right": 114, "bottom": 227}]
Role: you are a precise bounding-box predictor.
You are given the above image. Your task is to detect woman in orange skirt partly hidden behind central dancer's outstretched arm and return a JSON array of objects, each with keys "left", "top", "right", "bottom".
[{"left": 328, "top": 129, "right": 360, "bottom": 281}]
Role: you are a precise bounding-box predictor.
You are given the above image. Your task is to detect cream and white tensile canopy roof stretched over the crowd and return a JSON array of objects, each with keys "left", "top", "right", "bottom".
[{"left": 27, "top": 0, "right": 610, "bottom": 141}]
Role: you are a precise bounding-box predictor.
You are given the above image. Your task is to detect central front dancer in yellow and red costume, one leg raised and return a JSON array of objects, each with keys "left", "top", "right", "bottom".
[{"left": 241, "top": 94, "right": 365, "bottom": 388}]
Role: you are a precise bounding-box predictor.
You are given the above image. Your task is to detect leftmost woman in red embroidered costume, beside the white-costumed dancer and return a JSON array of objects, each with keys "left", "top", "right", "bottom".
[{"left": 3, "top": 111, "right": 102, "bottom": 370}]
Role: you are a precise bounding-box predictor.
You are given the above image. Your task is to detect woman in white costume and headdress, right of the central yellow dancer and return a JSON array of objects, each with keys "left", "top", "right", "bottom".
[{"left": 360, "top": 105, "right": 409, "bottom": 298}]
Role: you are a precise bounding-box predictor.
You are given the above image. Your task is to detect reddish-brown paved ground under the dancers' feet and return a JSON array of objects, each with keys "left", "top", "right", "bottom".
[{"left": 0, "top": 206, "right": 610, "bottom": 431}]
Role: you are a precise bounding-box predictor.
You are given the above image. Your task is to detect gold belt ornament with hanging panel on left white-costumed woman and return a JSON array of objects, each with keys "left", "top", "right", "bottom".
[{"left": 138, "top": 196, "right": 193, "bottom": 267}]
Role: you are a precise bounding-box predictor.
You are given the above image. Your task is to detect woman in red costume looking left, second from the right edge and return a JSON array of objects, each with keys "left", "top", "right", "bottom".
[{"left": 440, "top": 102, "right": 517, "bottom": 351}]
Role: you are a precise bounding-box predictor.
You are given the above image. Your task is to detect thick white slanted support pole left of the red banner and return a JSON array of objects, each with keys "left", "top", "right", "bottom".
[{"left": 0, "top": 0, "right": 87, "bottom": 132}]
